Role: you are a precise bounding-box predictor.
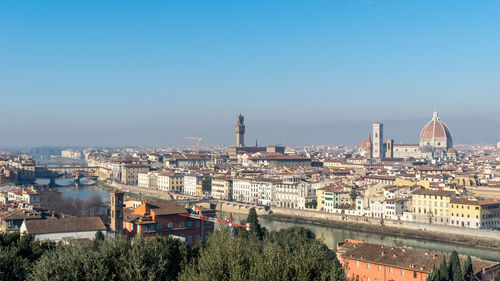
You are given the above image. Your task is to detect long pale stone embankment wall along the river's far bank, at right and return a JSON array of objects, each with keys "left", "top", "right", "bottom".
[{"left": 268, "top": 207, "right": 500, "bottom": 249}]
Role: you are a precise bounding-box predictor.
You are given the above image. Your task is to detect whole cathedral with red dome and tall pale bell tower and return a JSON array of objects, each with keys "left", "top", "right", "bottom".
[{"left": 358, "top": 111, "right": 457, "bottom": 159}]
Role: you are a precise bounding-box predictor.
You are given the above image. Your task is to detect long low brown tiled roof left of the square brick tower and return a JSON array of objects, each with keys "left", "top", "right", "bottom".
[{"left": 24, "top": 217, "right": 106, "bottom": 234}]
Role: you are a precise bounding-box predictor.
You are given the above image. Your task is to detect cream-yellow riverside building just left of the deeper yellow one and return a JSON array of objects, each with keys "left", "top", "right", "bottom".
[{"left": 412, "top": 189, "right": 455, "bottom": 225}]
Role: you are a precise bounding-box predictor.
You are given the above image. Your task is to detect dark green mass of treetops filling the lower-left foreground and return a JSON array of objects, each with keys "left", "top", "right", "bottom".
[{"left": 0, "top": 208, "right": 346, "bottom": 281}]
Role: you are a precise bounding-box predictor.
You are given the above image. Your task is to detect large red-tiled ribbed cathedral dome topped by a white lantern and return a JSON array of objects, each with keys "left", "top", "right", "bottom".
[{"left": 420, "top": 111, "right": 452, "bottom": 149}]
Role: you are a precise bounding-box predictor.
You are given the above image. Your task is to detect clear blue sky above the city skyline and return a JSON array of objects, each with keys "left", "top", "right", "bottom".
[{"left": 0, "top": 0, "right": 500, "bottom": 147}]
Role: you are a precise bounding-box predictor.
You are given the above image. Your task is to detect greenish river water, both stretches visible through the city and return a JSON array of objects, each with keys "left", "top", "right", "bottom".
[{"left": 30, "top": 178, "right": 500, "bottom": 261}]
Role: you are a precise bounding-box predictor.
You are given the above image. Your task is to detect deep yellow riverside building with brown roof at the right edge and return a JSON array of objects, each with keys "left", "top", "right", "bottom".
[{"left": 450, "top": 198, "right": 500, "bottom": 229}]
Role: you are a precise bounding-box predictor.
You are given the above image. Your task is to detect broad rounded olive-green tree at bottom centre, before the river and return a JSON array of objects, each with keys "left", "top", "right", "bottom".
[{"left": 179, "top": 227, "right": 346, "bottom": 281}]
